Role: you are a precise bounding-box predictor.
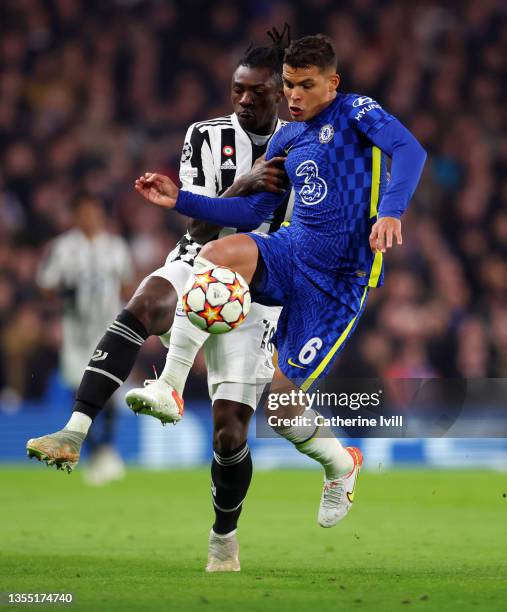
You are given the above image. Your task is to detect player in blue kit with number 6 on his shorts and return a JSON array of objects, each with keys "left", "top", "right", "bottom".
[{"left": 136, "top": 34, "right": 426, "bottom": 560}]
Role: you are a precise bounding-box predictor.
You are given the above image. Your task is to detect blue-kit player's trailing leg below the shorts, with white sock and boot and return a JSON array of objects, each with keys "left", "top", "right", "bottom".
[{"left": 265, "top": 368, "right": 363, "bottom": 527}]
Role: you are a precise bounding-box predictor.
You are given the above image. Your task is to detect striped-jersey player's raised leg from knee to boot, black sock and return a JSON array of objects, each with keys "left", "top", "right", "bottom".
[{"left": 26, "top": 276, "right": 185, "bottom": 472}]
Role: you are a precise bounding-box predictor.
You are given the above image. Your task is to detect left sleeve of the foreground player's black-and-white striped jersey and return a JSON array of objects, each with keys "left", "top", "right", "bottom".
[{"left": 180, "top": 123, "right": 217, "bottom": 197}]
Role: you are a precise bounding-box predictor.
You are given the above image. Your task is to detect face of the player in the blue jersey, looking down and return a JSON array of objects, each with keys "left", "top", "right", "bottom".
[{"left": 282, "top": 64, "right": 340, "bottom": 121}]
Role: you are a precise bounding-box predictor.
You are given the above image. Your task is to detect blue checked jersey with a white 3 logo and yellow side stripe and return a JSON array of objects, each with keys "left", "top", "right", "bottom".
[{"left": 266, "top": 94, "right": 394, "bottom": 292}]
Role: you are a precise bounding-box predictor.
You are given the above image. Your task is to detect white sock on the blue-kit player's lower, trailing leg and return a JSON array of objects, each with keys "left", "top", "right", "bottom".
[{"left": 273, "top": 410, "right": 354, "bottom": 480}]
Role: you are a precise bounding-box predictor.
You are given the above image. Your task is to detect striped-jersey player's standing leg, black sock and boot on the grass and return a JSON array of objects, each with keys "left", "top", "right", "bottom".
[{"left": 206, "top": 399, "right": 253, "bottom": 572}]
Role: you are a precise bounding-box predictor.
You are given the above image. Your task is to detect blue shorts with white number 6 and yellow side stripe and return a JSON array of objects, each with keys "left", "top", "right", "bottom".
[{"left": 248, "top": 228, "right": 368, "bottom": 391}]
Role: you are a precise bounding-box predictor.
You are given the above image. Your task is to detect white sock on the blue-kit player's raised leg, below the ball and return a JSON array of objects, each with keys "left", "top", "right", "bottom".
[{"left": 159, "top": 315, "right": 209, "bottom": 395}]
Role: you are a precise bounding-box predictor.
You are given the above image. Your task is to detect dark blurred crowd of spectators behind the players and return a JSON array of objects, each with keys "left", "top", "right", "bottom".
[{"left": 0, "top": 0, "right": 507, "bottom": 402}]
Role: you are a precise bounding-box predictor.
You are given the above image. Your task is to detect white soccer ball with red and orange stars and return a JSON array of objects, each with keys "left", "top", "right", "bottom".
[{"left": 182, "top": 266, "right": 252, "bottom": 334}]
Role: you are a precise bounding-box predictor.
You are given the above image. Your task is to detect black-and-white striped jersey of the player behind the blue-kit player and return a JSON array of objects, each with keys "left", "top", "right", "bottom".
[{"left": 169, "top": 113, "right": 293, "bottom": 263}]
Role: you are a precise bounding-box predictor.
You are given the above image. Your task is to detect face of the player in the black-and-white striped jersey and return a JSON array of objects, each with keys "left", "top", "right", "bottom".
[{"left": 231, "top": 66, "right": 283, "bottom": 134}]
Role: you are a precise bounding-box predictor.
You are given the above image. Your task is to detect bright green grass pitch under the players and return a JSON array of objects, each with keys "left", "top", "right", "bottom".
[{"left": 0, "top": 465, "right": 507, "bottom": 612}]
